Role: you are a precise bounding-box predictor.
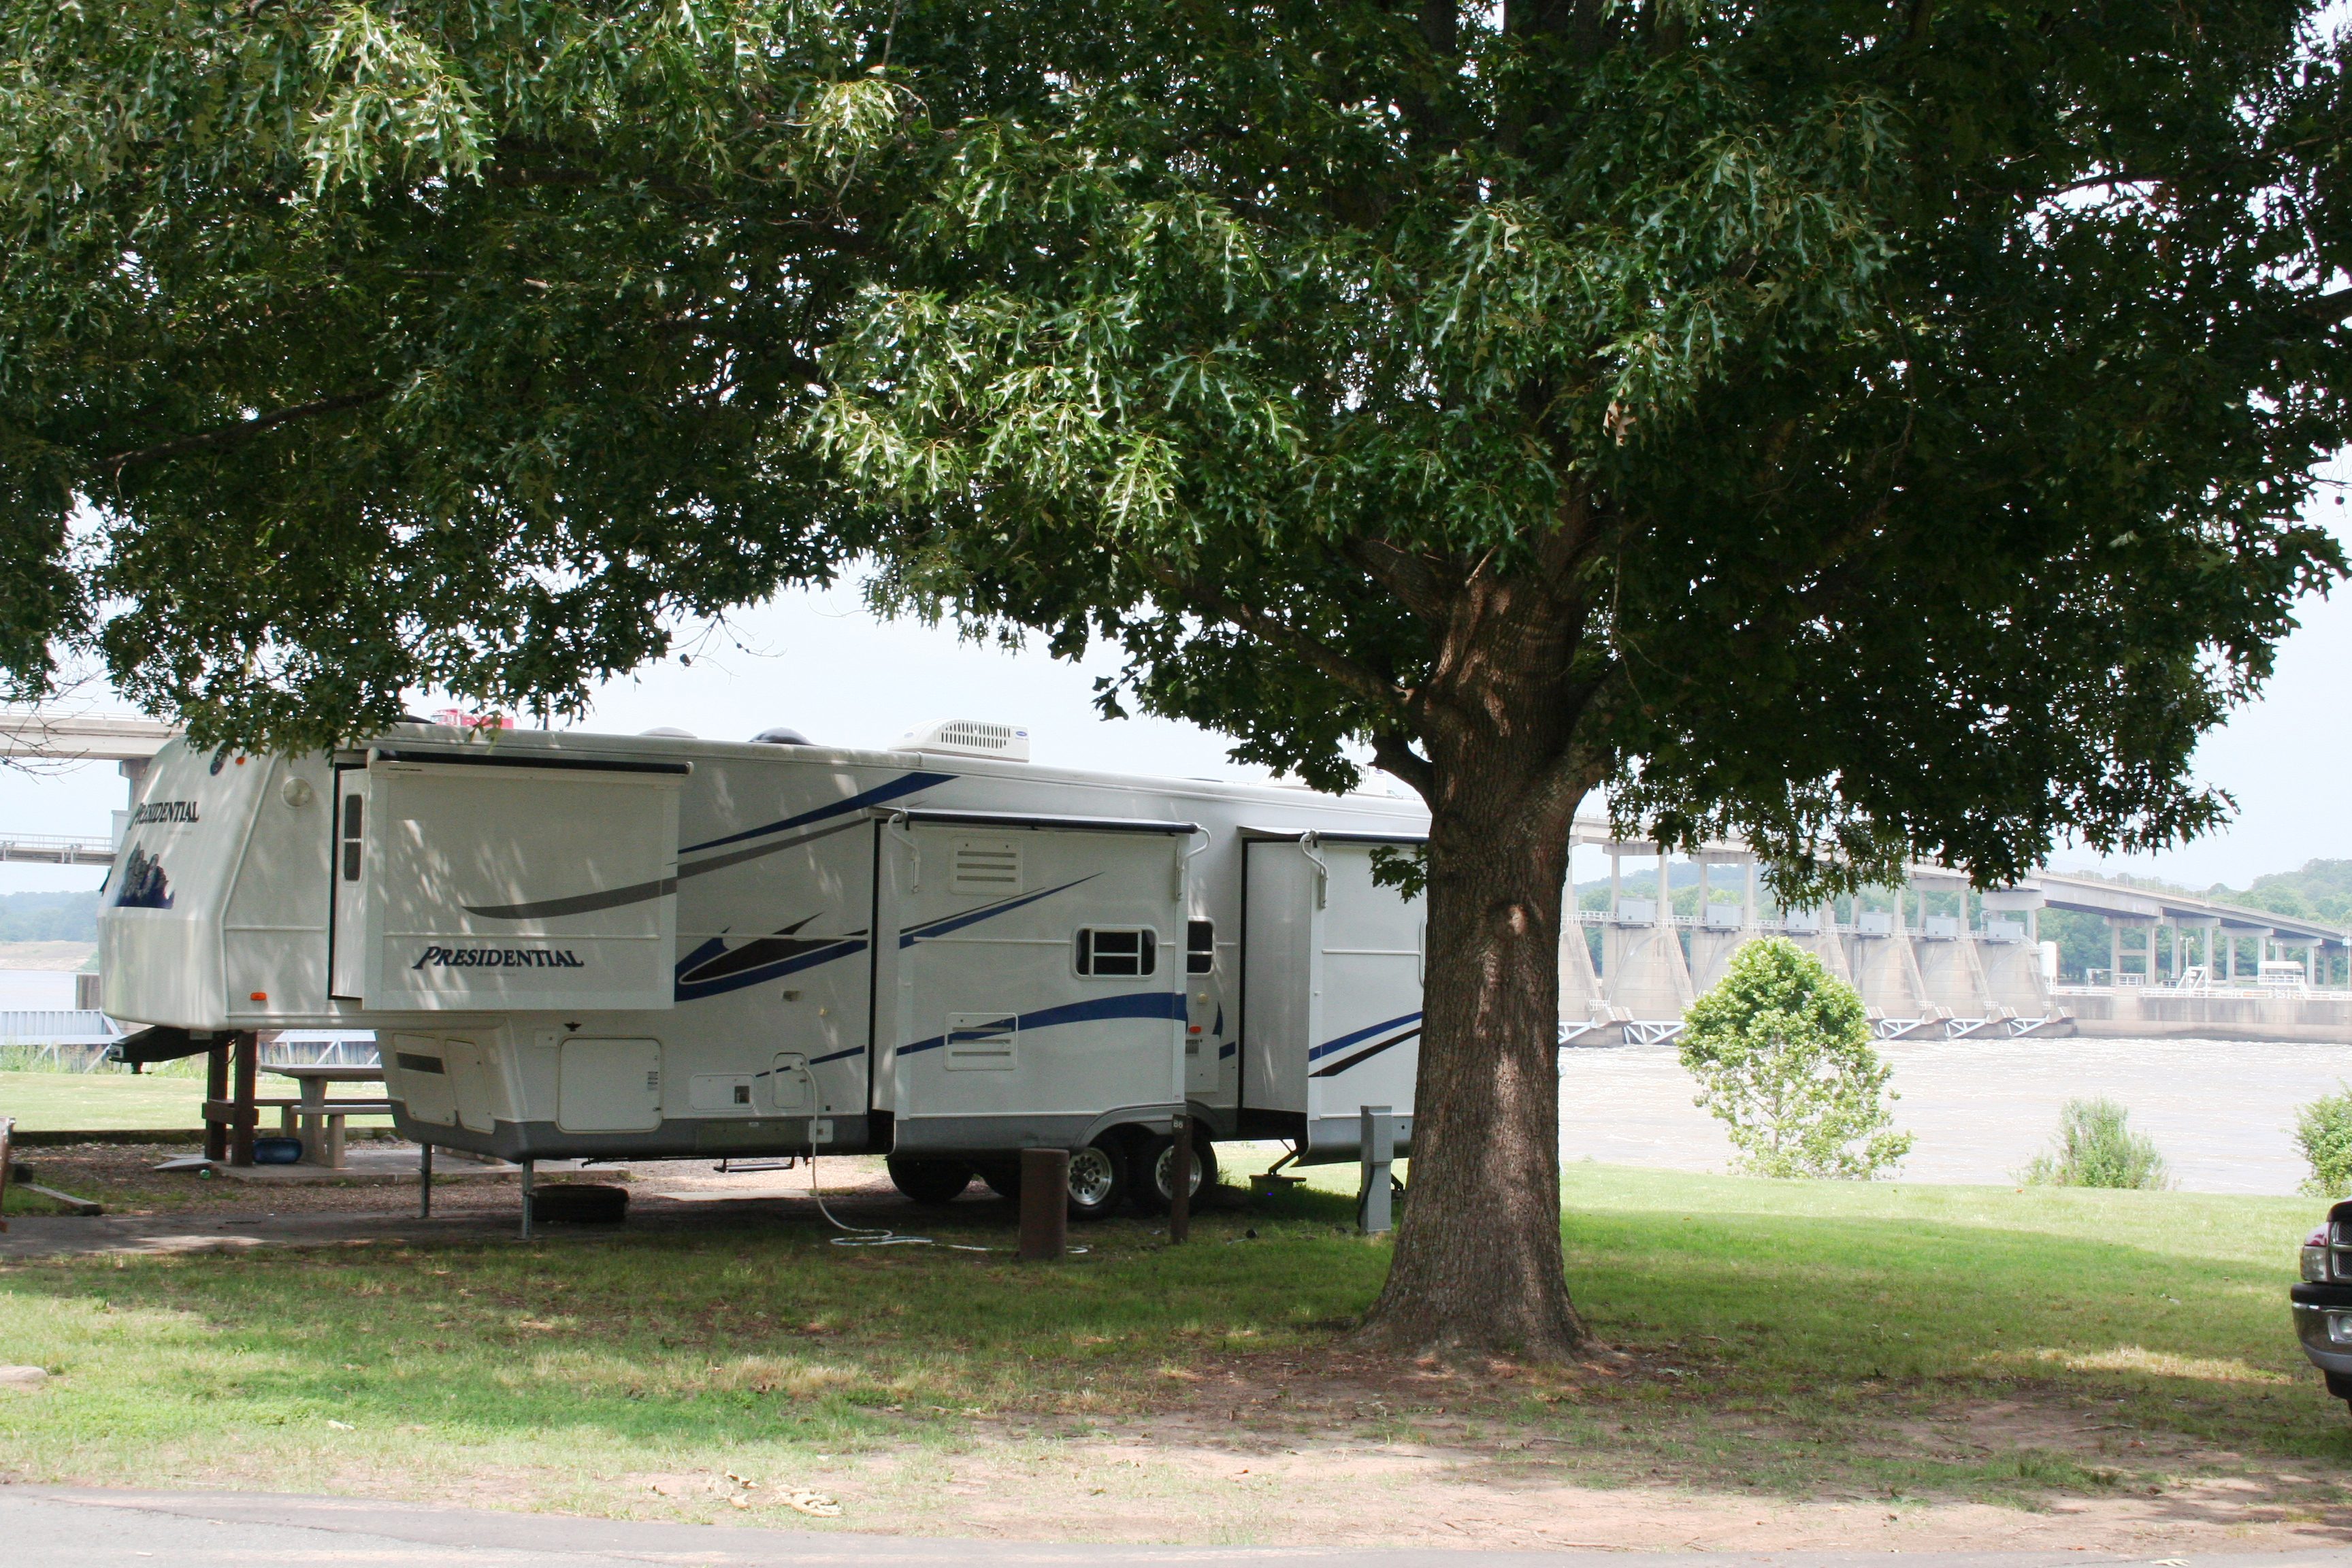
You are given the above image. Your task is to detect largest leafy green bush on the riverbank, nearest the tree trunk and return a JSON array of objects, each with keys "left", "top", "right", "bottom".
[{"left": 1682, "top": 938, "right": 1912, "bottom": 1180}]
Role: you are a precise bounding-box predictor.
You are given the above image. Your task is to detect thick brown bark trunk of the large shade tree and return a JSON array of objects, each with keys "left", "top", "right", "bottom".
[{"left": 1357, "top": 564, "right": 1592, "bottom": 1361}]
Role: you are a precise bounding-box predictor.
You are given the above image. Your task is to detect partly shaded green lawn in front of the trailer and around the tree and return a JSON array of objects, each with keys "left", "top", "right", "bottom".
[{"left": 0, "top": 1164, "right": 2352, "bottom": 1528}]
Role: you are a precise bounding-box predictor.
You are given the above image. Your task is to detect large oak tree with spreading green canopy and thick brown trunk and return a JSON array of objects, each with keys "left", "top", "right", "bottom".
[{"left": 0, "top": 0, "right": 2352, "bottom": 1356}]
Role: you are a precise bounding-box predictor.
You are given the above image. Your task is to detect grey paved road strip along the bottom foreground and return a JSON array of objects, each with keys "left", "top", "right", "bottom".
[{"left": 0, "top": 1486, "right": 2352, "bottom": 1568}]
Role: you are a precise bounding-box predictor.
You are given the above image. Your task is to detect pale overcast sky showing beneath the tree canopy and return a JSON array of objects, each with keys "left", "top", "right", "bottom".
[{"left": 0, "top": 514, "right": 2352, "bottom": 891}]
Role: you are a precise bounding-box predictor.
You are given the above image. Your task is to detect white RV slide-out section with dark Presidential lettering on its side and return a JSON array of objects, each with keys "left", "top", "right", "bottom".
[{"left": 353, "top": 747, "right": 689, "bottom": 1011}]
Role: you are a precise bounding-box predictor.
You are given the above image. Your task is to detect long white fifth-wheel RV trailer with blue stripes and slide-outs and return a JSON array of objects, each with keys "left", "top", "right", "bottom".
[{"left": 101, "top": 721, "right": 1428, "bottom": 1213}]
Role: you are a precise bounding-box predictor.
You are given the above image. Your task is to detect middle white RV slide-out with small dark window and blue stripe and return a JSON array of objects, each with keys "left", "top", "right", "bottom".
[{"left": 882, "top": 811, "right": 1192, "bottom": 1152}]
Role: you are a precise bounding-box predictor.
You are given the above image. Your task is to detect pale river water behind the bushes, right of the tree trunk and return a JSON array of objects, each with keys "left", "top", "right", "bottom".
[{"left": 1559, "top": 1039, "right": 2352, "bottom": 1194}]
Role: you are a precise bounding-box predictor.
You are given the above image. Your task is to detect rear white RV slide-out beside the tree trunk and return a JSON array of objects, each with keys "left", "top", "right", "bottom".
[{"left": 1244, "top": 837, "right": 1423, "bottom": 1164}]
